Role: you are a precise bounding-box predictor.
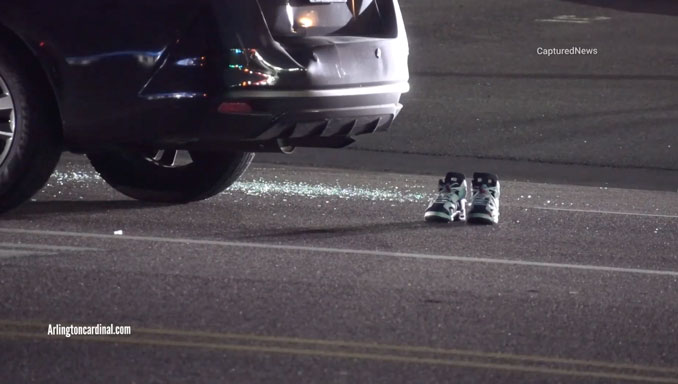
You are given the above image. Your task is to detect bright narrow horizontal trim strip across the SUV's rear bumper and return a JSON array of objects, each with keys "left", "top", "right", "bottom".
[{"left": 228, "top": 82, "right": 410, "bottom": 99}]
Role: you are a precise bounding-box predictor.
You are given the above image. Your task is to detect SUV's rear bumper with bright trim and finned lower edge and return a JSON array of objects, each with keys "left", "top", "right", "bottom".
[{"left": 201, "top": 82, "right": 409, "bottom": 151}]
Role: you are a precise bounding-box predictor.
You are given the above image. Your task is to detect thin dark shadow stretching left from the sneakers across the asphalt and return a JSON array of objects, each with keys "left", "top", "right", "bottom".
[{"left": 235, "top": 220, "right": 466, "bottom": 240}]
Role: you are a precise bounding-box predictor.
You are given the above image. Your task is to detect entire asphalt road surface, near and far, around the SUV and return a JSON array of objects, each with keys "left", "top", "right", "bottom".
[{"left": 0, "top": 0, "right": 678, "bottom": 384}]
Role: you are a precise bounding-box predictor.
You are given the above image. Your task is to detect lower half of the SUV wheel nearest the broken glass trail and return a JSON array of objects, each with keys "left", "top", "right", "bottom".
[{"left": 87, "top": 150, "right": 254, "bottom": 203}]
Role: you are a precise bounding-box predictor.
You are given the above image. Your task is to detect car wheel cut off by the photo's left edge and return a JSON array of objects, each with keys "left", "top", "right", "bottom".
[{"left": 0, "top": 46, "right": 61, "bottom": 212}]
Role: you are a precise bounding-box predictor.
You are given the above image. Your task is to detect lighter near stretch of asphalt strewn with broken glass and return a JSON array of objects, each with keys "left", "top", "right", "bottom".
[{"left": 0, "top": 156, "right": 678, "bottom": 383}]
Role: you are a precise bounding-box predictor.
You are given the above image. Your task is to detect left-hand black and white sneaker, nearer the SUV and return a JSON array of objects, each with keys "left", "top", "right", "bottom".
[{"left": 424, "top": 172, "right": 466, "bottom": 223}]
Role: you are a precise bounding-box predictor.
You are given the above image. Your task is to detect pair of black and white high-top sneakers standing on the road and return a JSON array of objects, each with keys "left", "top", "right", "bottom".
[{"left": 424, "top": 172, "right": 500, "bottom": 224}]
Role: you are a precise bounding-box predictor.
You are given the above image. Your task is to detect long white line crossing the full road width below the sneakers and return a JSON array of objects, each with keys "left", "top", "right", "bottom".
[{"left": 0, "top": 228, "right": 678, "bottom": 278}]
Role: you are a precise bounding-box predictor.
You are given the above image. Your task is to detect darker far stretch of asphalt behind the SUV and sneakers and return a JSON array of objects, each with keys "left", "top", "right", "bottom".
[{"left": 357, "top": 0, "right": 678, "bottom": 170}]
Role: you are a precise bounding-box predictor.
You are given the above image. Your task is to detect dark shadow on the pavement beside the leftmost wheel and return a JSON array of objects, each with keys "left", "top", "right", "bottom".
[{"left": 2, "top": 200, "right": 168, "bottom": 220}]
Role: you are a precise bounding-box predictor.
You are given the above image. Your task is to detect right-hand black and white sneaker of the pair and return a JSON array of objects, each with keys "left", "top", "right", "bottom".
[{"left": 468, "top": 173, "right": 501, "bottom": 224}]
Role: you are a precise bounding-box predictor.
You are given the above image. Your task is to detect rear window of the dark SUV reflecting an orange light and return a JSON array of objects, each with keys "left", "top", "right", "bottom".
[{"left": 259, "top": 0, "right": 397, "bottom": 41}]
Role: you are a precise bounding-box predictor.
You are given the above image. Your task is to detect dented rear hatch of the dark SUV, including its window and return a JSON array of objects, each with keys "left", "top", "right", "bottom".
[{"left": 252, "top": 0, "right": 409, "bottom": 89}]
